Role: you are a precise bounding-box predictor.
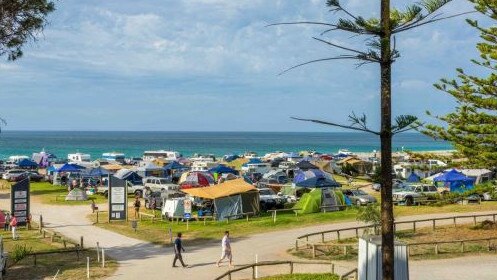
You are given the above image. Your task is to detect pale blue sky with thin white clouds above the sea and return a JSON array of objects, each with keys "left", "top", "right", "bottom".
[{"left": 0, "top": 0, "right": 488, "bottom": 132}]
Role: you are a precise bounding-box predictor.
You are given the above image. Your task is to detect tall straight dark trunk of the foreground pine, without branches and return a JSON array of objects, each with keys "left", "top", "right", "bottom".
[{"left": 380, "top": 0, "right": 394, "bottom": 280}]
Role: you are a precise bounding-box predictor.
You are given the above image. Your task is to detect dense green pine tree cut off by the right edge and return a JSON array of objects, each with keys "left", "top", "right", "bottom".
[{"left": 423, "top": 0, "right": 497, "bottom": 168}]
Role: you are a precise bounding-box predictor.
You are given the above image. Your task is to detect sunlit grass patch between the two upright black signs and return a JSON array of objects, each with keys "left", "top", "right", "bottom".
[{"left": 31, "top": 182, "right": 107, "bottom": 205}]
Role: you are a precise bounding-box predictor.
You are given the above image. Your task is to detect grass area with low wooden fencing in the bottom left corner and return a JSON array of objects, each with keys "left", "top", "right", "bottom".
[{"left": 0, "top": 229, "right": 117, "bottom": 279}]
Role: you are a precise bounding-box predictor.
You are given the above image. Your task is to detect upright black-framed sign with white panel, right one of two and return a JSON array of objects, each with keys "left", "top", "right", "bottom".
[{"left": 109, "top": 176, "right": 128, "bottom": 221}]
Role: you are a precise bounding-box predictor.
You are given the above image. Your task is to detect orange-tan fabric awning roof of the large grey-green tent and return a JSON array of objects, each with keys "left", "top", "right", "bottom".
[{"left": 182, "top": 179, "right": 256, "bottom": 199}]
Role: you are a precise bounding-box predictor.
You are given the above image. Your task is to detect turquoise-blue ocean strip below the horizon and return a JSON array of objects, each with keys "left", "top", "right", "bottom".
[{"left": 0, "top": 131, "right": 452, "bottom": 159}]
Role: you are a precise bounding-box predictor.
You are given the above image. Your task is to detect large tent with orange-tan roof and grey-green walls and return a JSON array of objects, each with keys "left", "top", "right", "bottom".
[{"left": 182, "top": 178, "right": 259, "bottom": 220}]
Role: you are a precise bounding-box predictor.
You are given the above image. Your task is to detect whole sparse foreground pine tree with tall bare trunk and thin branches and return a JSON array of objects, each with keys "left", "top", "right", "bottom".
[{"left": 273, "top": 0, "right": 465, "bottom": 280}]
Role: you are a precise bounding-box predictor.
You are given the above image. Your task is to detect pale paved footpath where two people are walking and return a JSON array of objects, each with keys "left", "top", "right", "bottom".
[{"left": 0, "top": 195, "right": 497, "bottom": 280}]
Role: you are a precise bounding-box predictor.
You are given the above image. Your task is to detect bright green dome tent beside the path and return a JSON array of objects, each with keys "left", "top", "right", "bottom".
[{"left": 294, "top": 188, "right": 345, "bottom": 214}]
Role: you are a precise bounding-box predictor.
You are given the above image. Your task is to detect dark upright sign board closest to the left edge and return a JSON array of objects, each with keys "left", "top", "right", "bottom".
[{"left": 10, "top": 178, "right": 29, "bottom": 226}]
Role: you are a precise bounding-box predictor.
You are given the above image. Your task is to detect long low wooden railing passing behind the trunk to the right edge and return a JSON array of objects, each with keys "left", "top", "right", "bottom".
[{"left": 295, "top": 213, "right": 497, "bottom": 251}]
